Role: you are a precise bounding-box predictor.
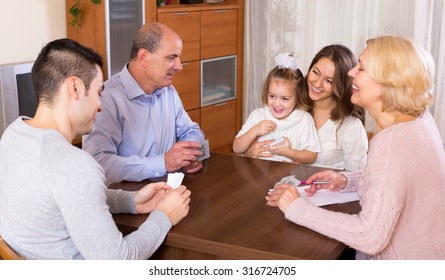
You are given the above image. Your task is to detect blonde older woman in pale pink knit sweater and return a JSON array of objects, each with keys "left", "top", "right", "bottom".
[{"left": 266, "top": 36, "right": 445, "bottom": 259}]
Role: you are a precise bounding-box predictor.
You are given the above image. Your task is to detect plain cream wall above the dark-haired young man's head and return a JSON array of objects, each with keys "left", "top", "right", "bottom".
[{"left": 0, "top": 0, "right": 66, "bottom": 64}]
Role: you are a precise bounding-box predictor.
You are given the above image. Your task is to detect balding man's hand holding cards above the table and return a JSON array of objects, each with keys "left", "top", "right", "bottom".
[{"left": 164, "top": 141, "right": 202, "bottom": 173}]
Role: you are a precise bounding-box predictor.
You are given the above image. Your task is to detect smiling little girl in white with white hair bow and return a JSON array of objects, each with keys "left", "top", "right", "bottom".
[{"left": 233, "top": 53, "right": 320, "bottom": 164}]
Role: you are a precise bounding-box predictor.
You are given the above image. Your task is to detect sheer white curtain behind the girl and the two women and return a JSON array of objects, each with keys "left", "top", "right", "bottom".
[{"left": 243, "top": 0, "right": 445, "bottom": 146}]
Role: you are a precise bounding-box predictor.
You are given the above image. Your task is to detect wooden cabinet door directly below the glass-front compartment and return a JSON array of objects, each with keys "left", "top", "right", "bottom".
[{"left": 201, "top": 100, "right": 236, "bottom": 150}]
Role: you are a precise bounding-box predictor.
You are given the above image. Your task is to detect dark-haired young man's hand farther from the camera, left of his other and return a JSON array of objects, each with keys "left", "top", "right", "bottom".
[{"left": 134, "top": 182, "right": 171, "bottom": 214}]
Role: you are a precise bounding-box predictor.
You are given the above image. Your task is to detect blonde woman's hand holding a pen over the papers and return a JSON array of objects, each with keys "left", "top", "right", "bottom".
[{"left": 305, "top": 170, "right": 348, "bottom": 196}]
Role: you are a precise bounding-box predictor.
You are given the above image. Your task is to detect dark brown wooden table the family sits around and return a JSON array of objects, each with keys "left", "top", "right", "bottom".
[{"left": 112, "top": 153, "right": 360, "bottom": 260}]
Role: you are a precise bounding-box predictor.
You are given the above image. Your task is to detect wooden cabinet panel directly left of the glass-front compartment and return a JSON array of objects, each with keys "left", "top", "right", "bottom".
[{"left": 173, "top": 61, "right": 201, "bottom": 111}]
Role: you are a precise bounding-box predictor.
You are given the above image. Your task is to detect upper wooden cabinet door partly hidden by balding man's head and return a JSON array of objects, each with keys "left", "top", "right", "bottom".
[{"left": 158, "top": 12, "right": 201, "bottom": 61}]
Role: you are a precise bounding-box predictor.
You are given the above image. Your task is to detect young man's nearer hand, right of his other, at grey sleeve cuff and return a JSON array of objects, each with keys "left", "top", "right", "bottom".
[{"left": 156, "top": 185, "right": 191, "bottom": 225}]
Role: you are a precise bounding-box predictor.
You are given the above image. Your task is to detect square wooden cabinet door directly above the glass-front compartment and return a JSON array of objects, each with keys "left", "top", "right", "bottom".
[{"left": 201, "top": 9, "right": 237, "bottom": 59}]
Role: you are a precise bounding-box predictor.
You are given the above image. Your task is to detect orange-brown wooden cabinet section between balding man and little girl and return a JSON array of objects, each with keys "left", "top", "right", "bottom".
[{"left": 157, "top": 0, "right": 244, "bottom": 150}]
